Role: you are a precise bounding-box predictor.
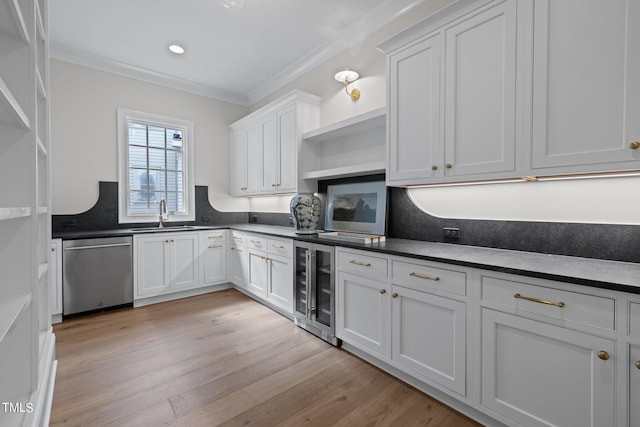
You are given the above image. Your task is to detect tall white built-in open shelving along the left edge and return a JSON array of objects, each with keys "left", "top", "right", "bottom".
[{"left": 0, "top": 0, "right": 56, "bottom": 426}]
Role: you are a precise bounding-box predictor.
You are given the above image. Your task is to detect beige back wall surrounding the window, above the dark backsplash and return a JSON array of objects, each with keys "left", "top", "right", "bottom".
[{"left": 51, "top": 60, "right": 249, "bottom": 215}]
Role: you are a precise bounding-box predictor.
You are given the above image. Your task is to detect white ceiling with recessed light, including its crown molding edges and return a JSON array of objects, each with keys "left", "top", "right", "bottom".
[{"left": 49, "top": 0, "right": 424, "bottom": 105}]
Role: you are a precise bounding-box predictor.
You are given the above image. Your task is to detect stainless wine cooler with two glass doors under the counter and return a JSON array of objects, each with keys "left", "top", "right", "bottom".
[{"left": 293, "top": 241, "right": 340, "bottom": 346}]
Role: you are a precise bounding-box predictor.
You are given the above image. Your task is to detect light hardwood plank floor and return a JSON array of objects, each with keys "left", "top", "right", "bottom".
[{"left": 51, "top": 290, "right": 477, "bottom": 427}]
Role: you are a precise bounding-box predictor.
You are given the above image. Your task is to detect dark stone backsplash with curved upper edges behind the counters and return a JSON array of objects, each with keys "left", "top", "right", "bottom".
[{"left": 52, "top": 179, "right": 640, "bottom": 262}]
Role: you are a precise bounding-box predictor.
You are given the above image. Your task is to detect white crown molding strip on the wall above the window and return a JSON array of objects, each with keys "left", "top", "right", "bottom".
[{"left": 50, "top": 43, "right": 250, "bottom": 107}]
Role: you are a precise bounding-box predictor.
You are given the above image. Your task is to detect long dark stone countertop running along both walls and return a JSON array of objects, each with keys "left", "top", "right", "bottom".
[{"left": 54, "top": 224, "right": 640, "bottom": 293}]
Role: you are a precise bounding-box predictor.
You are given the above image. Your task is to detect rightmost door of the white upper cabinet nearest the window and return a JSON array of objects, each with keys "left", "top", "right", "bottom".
[{"left": 277, "top": 105, "right": 298, "bottom": 192}]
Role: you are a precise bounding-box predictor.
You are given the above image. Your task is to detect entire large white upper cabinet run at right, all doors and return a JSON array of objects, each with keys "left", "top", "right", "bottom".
[{"left": 379, "top": 0, "right": 640, "bottom": 186}]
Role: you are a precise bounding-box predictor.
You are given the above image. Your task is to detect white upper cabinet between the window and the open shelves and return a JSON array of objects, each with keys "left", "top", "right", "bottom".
[{"left": 229, "top": 91, "right": 320, "bottom": 196}]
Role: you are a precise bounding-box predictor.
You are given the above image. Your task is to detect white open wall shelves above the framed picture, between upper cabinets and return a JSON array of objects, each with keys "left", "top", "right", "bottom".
[{"left": 302, "top": 107, "right": 386, "bottom": 180}]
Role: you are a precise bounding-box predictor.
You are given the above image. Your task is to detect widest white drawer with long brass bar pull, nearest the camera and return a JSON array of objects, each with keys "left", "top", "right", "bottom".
[{"left": 482, "top": 276, "right": 615, "bottom": 331}]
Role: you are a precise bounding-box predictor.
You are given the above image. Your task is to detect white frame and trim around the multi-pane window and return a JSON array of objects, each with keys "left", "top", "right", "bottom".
[{"left": 117, "top": 108, "right": 196, "bottom": 224}]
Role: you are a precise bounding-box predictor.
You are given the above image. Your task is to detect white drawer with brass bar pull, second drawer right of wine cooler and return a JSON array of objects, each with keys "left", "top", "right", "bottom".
[{"left": 391, "top": 261, "right": 467, "bottom": 295}]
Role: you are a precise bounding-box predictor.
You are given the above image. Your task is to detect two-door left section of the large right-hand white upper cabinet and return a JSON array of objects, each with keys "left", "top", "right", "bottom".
[{"left": 380, "top": 0, "right": 517, "bottom": 185}]
